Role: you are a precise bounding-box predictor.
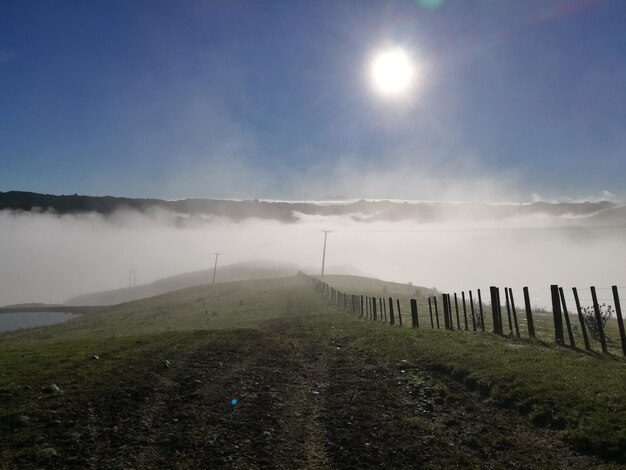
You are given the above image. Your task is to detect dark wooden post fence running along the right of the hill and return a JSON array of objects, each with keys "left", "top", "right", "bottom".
[{"left": 300, "top": 273, "right": 626, "bottom": 356}]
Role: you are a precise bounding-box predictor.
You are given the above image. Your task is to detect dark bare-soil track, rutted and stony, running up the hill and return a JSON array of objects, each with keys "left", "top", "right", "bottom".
[{"left": 16, "top": 319, "right": 610, "bottom": 469}]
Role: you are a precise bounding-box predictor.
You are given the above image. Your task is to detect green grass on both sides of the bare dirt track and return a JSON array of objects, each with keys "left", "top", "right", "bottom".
[{"left": 0, "top": 276, "right": 626, "bottom": 461}]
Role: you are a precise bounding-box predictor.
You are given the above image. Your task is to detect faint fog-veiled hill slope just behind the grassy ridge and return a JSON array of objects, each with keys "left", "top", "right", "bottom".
[{"left": 65, "top": 261, "right": 300, "bottom": 306}]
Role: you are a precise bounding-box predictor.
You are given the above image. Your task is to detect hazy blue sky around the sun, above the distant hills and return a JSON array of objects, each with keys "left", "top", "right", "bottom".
[{"left": 0, "top": 0, "right": 626, "bottom": 200}]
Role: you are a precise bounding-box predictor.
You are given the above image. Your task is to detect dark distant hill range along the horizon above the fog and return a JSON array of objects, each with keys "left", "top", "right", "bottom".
[{"left": 0, "top": 191, "right": 626, "bottom": 225}]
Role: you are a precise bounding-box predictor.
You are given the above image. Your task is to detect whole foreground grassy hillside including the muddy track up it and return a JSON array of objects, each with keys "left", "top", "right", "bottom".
[{"left": 0, "top": 276, "right": 626, "bottom": 468}]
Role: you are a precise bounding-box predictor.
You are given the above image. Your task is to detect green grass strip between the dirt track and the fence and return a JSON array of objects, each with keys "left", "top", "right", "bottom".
[{"left": 311, "top": 316, "right": 626, "bottom": 459}]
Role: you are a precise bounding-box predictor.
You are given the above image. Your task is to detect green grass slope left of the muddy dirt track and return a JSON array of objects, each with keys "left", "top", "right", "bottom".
[{"left": 0, "top": 277, "right": 333, "bottom": 467}]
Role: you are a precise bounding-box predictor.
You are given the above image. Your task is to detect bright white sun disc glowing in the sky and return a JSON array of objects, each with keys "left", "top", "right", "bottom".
[{"left": 371, "top": 47, "right": 415, "bottom": 95}]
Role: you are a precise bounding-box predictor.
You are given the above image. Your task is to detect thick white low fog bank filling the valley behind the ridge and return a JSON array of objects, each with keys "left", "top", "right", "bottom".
[{"left": 0, "top": 203, "right": 626, "bottom": 305}]
